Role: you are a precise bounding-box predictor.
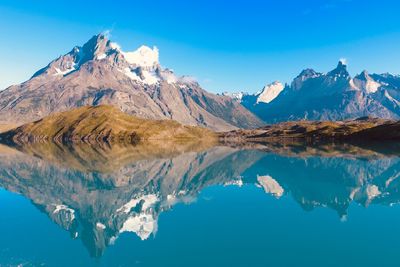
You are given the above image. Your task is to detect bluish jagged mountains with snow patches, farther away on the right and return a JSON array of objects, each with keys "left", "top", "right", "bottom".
[{"left": 223, "top": 61, "right": 400, "bottom": 123}]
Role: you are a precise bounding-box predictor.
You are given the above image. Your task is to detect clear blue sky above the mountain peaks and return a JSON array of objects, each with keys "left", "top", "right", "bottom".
[{"left": 0, "top": 0, "right": 400, "bottom": 92}]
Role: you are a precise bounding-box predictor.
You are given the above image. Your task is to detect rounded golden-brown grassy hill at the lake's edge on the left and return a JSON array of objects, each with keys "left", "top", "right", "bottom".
[{"left": 0, "top": 106, "right": 216, "bottom": 146}]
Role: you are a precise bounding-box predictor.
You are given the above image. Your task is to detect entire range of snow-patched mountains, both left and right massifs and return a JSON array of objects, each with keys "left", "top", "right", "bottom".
[{"left": 0, "top": 34, "right": 400, "bottom": 131}]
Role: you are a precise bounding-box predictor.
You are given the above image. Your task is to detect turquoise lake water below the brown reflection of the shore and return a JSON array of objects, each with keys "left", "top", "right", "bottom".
[{"left": 0, "top": 147, "right": 400, "bottom": 266}]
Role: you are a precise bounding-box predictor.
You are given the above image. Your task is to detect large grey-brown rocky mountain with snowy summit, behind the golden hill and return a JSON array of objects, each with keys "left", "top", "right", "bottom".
[{"left": 0, "top": 34, "right": 262, "bottom": 130}]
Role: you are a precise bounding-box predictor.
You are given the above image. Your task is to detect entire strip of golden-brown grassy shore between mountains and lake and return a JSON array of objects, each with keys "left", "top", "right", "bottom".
[{"left": 0, "top": 105, "right": 400, "bottom": 147}]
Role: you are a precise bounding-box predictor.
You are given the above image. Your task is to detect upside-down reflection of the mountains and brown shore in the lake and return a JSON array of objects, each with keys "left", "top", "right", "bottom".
[{"left": 0, "top": 144, "right": 400, "bottom": 262}]
